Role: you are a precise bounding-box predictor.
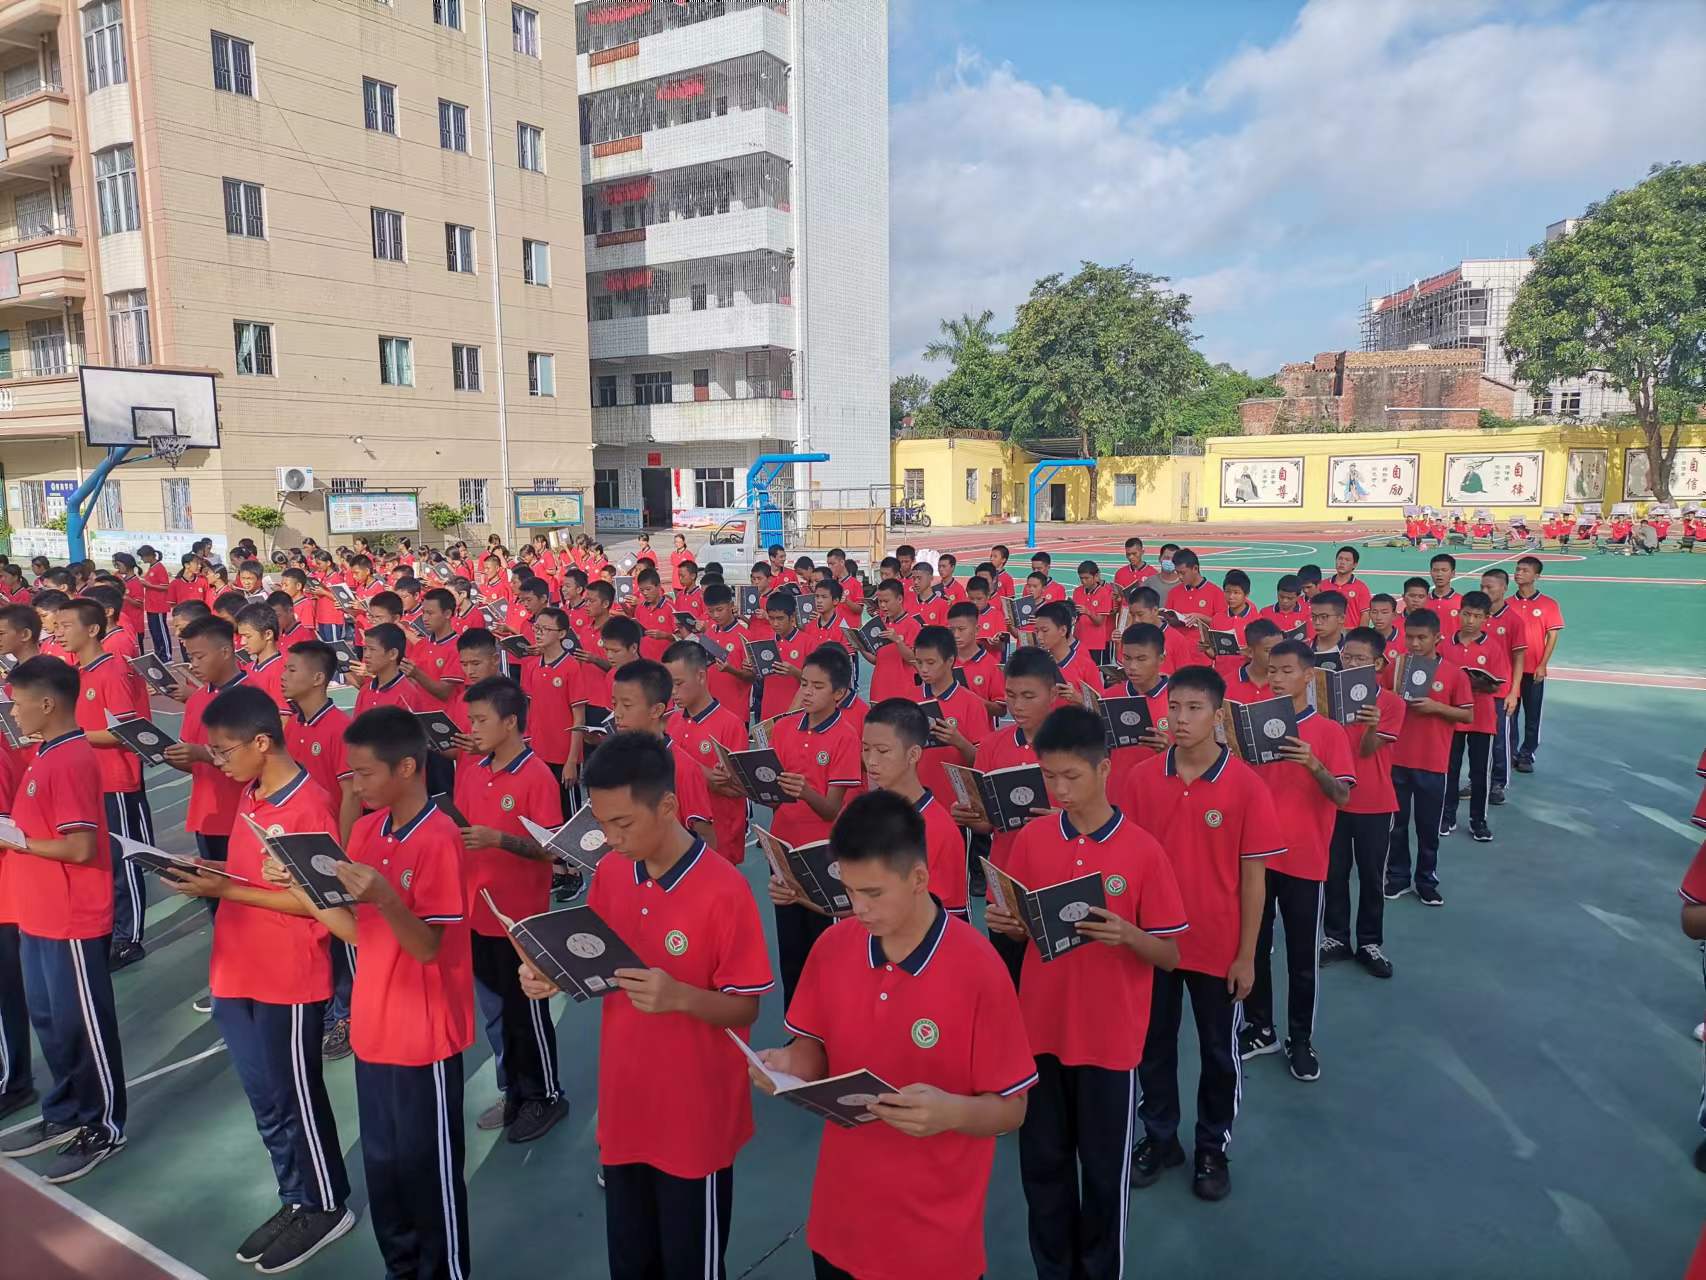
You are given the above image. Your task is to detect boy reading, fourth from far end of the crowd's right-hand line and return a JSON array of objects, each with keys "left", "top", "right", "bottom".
[{"left": 1385, "top": 608, "right": 1474, "bottom": 906}]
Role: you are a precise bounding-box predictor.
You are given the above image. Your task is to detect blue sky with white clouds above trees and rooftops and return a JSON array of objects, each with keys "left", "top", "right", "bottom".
[{"left": 889, "top": 0, "right": 1706, "bottom": 375}]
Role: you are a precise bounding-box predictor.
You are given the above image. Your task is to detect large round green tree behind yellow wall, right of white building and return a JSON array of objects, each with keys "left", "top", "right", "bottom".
[{"left": 1005, "top": 263, "right": 1206, "bottom": 519}]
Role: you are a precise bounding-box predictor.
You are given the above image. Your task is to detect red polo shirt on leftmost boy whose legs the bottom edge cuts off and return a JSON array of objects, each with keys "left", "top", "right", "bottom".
[{"left": 348, "top": 804, "right": 474, "bottom": 1067}]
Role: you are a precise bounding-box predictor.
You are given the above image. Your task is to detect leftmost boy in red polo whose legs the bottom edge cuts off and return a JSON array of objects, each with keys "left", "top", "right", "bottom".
[{"left": 268, "top": 707, "right": 474, "bottom": 1277}]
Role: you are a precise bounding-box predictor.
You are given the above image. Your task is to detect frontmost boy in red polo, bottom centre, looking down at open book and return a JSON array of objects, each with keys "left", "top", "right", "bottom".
[{"left": 754, "top": 792, "right": 1037, "bottom": 1280}]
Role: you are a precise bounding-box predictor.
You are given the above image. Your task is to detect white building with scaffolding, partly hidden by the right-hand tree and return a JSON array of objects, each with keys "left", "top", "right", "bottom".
[{"left": 1361, "top": 218, "right": 1633, "bottom": 422}]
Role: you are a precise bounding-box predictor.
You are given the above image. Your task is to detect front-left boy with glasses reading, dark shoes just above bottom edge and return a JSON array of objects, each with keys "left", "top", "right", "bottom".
[{"left": 164, "top": 684, "right": 355, "bottom": 1273}]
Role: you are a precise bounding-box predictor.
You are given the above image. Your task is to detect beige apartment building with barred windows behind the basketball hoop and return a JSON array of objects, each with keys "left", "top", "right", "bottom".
[{"left": 0, "top": 0, "right": 592, "bottom": 555}]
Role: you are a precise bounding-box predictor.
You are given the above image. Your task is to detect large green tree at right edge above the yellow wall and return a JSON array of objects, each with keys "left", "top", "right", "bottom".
[{"left": 1505, "top": 164, "right": 1706, "bottom": 500}]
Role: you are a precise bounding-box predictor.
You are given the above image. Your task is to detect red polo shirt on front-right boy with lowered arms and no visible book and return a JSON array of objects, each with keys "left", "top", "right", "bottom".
[{"left": 1117, "top": 748, "right": 1286, "bottom": 978}]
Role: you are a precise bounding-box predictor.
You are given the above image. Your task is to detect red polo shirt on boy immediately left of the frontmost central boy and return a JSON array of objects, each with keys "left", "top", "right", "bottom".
[{"left": 587, "top": 841, "right": 775, "bottom": 1178}]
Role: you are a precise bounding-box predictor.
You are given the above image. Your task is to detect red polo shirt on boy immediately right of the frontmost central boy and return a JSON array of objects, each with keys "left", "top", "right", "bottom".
[{"left": 1007, "top": 809, "right": 1187, "bottom": 1072}]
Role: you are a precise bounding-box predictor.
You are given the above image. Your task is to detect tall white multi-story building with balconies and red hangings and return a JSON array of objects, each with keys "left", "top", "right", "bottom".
[{"left": 575, "top": 0, "right": 889, "bottom": 527}]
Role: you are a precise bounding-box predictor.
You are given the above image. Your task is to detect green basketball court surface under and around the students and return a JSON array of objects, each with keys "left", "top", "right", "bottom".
[{"left": 0, "top": 526, "right": 1706, "bottom": 1280}]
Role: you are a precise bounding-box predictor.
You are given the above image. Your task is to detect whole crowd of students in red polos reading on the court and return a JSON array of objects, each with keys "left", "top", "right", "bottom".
[{"left": 0, "top": 536, "right": 1589, "bottom": 1280}]
